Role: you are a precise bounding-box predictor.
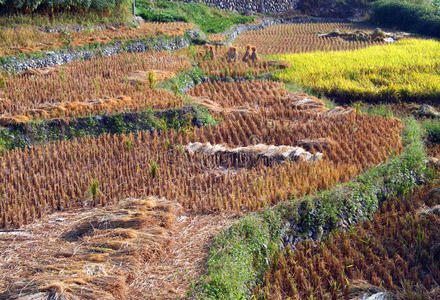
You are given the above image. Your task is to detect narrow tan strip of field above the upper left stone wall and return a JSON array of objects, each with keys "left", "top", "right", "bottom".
[{"left": 0, "top": 22, "right": 194, "bottom": 56}]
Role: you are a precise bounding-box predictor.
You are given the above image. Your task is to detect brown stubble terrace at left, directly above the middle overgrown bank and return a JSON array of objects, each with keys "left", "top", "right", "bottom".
[{"left": 0, "top": 52, "right": 187, "bottom": 120}]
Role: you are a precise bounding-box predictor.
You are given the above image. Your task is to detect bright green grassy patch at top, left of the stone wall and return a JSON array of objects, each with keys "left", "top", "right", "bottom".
[{"left": 136, "top": 0, "right": 254, "bottom": 33}]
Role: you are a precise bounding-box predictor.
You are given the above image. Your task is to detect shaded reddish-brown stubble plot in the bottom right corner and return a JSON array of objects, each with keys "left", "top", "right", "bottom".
[{"left": 255, "top": 183, "right": 440, "bottom": 299}]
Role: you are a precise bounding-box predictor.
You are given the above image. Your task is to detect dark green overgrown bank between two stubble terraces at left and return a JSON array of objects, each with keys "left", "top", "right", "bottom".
[{"left": 0, "top": 105, "right": 217, "bottom": 154}]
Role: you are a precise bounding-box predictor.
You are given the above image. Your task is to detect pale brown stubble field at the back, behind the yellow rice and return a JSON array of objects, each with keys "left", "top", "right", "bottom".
[{"left": 235, "top": 23, "right": 378, "bottom": 54}]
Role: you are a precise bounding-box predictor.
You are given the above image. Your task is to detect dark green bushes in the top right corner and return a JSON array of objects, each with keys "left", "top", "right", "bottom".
[{"left": 371, "top": 0, "right": 440, "bottom": 37}]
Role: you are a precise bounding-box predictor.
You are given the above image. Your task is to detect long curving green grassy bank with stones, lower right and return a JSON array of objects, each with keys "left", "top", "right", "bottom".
[{"left": 191, "top": 119, "right": 429, "bottom": 299}]
